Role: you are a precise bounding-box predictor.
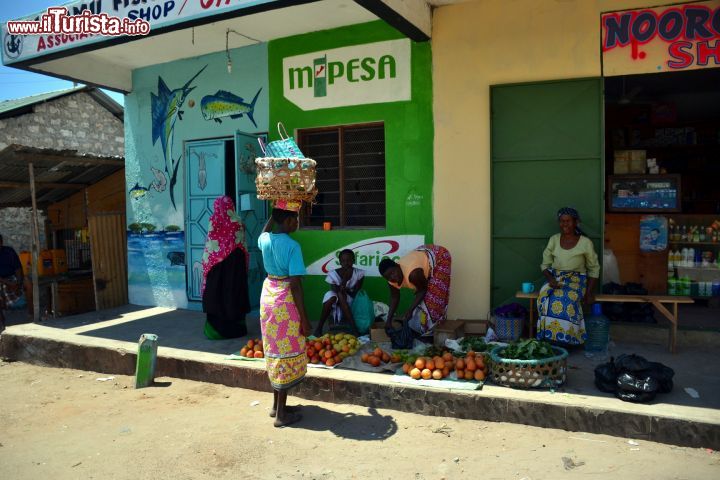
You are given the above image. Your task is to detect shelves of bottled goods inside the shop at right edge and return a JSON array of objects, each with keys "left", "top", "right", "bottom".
[{"left": 667, "top": 215, "right": 720, "bottom": 298}]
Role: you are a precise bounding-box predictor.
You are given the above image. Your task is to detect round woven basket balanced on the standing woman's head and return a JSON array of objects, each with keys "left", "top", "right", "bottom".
[{"left": 255, "top": 157, "right": 317, "bottom": 203}]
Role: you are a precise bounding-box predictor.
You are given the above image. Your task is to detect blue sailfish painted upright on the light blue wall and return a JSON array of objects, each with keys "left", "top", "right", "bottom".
[{"left": 150, "top": 65, "right": 207, "bottom": 210}]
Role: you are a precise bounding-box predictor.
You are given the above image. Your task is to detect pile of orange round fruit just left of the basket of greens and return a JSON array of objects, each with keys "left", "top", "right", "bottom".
[{"left": 403, "top": 351, "right": 488, "bottom": 381}]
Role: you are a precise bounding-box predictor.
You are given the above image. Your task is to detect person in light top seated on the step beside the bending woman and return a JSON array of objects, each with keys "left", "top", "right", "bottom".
[{"left": 315, "top": 249, "right": 365, "bottom": 337}]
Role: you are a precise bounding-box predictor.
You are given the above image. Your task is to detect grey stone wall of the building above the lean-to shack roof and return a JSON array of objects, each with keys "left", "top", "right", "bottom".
[{"left": 0, "top": 92, "right": 125, "bottom": 156}]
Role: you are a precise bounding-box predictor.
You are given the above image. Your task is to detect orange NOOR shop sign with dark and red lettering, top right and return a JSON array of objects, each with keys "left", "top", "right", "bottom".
[{"left": 602, "top": 0, "right": 720, "bottom": 76}]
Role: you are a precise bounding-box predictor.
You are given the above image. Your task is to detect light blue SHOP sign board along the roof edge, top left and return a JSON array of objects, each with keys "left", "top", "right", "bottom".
[{"left": 1, "top": 0, "right": 277, "bottom": 65}]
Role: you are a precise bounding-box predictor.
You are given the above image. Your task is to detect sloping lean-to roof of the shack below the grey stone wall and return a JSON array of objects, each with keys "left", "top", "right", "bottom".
[{"left": 0, "top": 145, "right": 125, "bottom": 206}]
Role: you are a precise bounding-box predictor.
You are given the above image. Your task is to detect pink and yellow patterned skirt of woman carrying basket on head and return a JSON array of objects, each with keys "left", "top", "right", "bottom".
[{"left": 260, "top": 276, "right": 307, "bottom": 390}]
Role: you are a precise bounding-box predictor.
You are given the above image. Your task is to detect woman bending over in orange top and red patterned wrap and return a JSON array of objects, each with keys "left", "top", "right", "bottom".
[{"left": 378, "top": 245, "right": 452, "bottom": 336}]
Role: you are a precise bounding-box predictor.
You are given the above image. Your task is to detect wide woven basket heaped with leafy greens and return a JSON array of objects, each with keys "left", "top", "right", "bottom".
[{"left": 490, "top": 340, "right": 568, "bottom": 388}]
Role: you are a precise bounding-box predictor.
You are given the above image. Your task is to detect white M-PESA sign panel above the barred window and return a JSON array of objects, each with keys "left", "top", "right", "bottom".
[{"left": 283, "top": 39, "right": 411, "bottom": 110}]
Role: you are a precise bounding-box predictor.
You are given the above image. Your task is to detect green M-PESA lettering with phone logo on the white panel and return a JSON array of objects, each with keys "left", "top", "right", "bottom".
[{"left": 288, "top": 55, "right": 397, "bottom": 97}]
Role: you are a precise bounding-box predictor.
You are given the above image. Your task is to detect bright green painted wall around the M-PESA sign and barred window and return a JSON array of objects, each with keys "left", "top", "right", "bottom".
[{"left": 268, "top": 22, "right": 433, "bottom": 320}]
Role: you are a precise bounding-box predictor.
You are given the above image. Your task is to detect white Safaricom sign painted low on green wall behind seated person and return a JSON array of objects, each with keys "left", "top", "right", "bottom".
[{"left": 306, "top": 235, "right": 425, "bottom": 277}]
